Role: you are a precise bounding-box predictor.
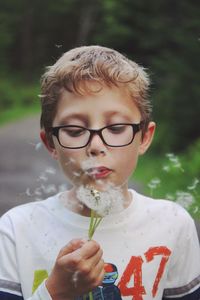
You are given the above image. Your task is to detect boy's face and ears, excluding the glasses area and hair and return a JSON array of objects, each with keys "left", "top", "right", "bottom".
[{"left": 41, "top": 83, "right": 155, "bottom": 190}]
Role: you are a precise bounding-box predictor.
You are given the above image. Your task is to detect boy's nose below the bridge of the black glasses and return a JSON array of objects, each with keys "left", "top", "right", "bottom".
[{"left": 87, "top": 133, "right": 107, "bottom": 156}]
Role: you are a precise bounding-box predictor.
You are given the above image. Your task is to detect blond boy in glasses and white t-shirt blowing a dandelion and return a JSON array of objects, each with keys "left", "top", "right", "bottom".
[{"left": 0, "top": 46, "right": 200, "bottom": 300}]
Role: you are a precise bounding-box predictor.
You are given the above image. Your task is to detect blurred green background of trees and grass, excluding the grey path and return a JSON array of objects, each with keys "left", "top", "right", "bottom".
[{"left": 0, "top": 0, "right": 200, "bottom": 216}]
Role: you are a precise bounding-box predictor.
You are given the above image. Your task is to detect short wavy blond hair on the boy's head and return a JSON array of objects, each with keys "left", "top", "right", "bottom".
[{"left": 41, "top": 46, "right": 151, "bottom": 133}]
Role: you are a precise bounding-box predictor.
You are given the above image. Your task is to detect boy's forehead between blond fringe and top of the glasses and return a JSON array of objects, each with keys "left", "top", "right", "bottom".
[{"left": 55, "top": 83, "right": 140, "bottom": 121}]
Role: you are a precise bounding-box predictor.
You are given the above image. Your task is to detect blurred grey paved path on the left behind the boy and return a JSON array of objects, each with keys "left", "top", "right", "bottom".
[{"left": 0, "top": 116, "right": 66, "bottom": 215}]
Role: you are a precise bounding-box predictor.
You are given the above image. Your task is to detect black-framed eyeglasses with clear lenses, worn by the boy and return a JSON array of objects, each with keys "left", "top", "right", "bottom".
[{"left": 50, "top": 121, "right": 143, "bottom": 149}]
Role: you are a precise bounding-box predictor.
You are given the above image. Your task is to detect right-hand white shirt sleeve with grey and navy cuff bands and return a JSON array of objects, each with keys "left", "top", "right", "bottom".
[{"left": 164, "top": 213, "right": 200, "bottom": 299}]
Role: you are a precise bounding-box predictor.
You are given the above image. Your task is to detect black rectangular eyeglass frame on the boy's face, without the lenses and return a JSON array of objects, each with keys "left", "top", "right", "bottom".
[{"left": 49, "top": 121, "right": 144, "bottom": 149}]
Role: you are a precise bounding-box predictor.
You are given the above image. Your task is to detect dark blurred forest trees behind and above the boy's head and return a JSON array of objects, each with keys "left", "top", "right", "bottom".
[{"left": 0, "top": 0, "right": 200, "bottom": 151}]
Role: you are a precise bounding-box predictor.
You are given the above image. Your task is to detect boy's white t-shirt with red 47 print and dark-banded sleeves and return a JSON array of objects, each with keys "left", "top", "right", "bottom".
[{"left": 0, "top": 190, "right": 200, "bottom": 300}]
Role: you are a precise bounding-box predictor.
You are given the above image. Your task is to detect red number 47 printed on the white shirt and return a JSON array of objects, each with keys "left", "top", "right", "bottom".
[{"left": 118, "top": 246, "right": 171, "bottom": 300}]
